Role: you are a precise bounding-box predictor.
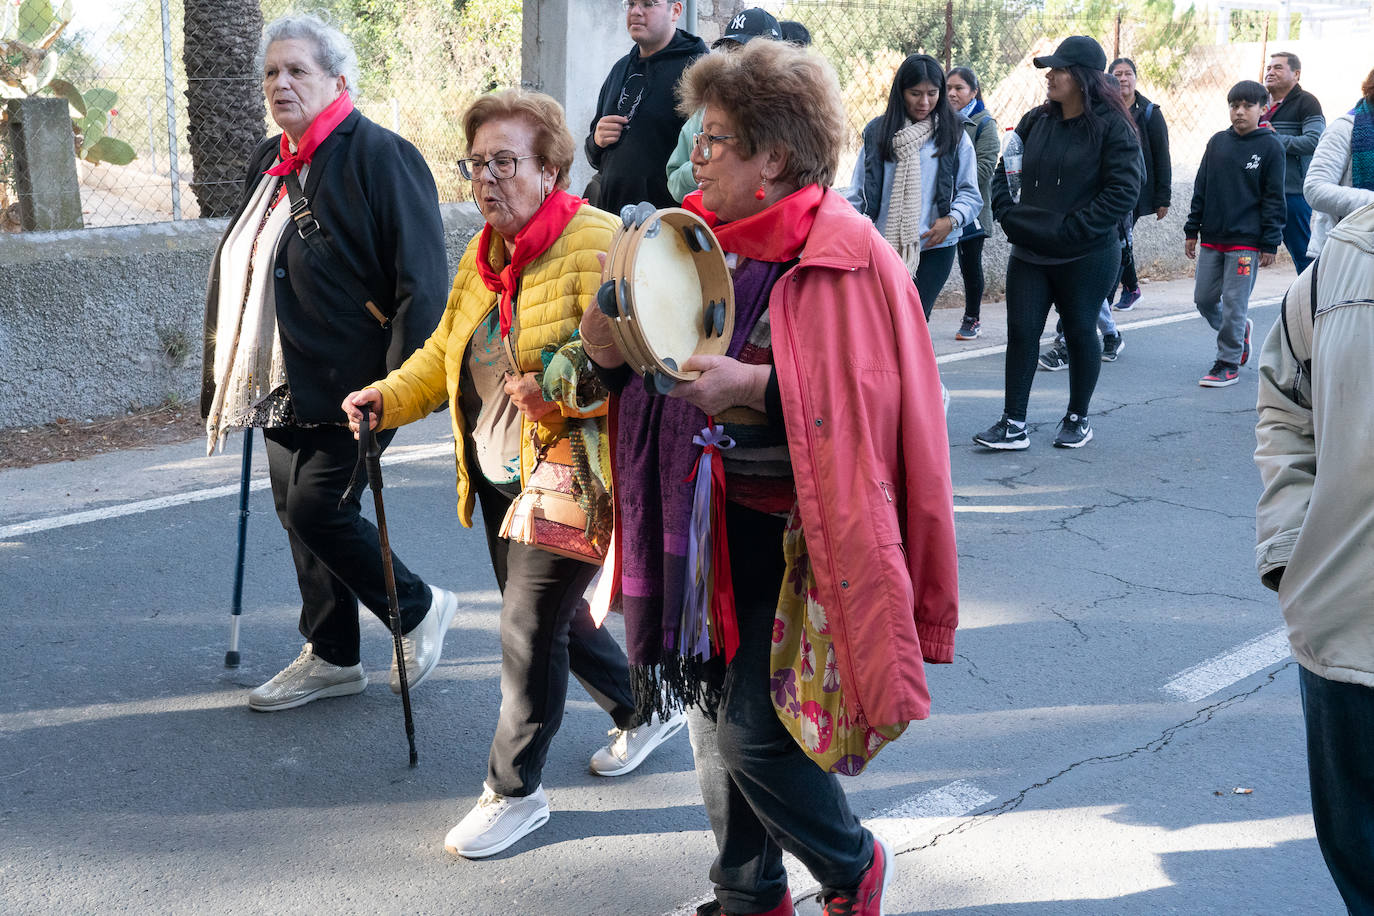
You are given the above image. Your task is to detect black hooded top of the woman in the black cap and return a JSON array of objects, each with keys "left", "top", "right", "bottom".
[{"left": 992, "top": 106, "right": 1145, "bottom": 258}]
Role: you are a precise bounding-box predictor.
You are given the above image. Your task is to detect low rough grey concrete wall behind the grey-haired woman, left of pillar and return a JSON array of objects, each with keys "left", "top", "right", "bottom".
[{"left": 0, "top": 203, "right": 482, "bottom": 428}]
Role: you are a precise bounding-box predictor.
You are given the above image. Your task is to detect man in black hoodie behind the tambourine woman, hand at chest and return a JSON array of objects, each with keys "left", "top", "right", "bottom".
[{"left": 585, "top": 0, "right": 706, "bottom": 213}]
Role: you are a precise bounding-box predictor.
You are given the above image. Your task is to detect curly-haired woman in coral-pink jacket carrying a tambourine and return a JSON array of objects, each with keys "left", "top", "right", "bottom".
[{"left": 581, "top": 41, "right": 958, "bottom": 916}]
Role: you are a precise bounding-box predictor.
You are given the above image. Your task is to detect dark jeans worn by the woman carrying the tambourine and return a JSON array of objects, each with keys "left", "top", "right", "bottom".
[{"left": 688, "top": 504, "right": 874, "bottom": 913}]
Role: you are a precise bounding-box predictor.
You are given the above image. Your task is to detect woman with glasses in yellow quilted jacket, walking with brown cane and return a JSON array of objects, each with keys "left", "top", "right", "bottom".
[{"left": 344, "top": 89, "right": 683, "bottom": 858}]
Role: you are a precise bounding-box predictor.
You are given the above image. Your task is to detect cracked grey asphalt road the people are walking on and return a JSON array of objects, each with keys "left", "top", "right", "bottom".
[{"left": 0, "top": 270, "right": 1341, "bottom": 916}]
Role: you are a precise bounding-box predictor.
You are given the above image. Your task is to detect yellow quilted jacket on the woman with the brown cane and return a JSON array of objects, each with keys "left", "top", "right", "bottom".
[{"left": 368, "top": 206, "right": 618, "bottom": 527}]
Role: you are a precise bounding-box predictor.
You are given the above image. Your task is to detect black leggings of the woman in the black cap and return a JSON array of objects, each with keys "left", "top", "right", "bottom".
[{"left": 1004, "top": 243, "right": 1121, "bottom": 422}]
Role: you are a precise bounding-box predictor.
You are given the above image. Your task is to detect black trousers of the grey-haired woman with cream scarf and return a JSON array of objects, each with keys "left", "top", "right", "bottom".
[{"left": 262, "top": 426, "right": 431, "bottom": 665}]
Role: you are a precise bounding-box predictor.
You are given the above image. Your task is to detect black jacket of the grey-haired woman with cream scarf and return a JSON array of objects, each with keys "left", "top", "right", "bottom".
[{"left": 201, "top": 111, "right": 448, "bottom": 423}]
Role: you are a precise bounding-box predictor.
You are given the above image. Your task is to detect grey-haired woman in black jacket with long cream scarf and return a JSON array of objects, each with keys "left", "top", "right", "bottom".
[{"left": 201, "top": 16, "right": 456, "bottom": 713}]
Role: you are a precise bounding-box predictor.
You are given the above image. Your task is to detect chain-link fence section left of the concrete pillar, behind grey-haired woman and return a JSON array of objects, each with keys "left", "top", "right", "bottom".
[{"left": 0, "top": 0, "right": 521, "bottom": 231}]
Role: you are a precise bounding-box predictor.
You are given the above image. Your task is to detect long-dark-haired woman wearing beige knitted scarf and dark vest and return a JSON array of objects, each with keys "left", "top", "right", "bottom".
[{"left": 846, "top": 54, "right": 982, "bottom": 319}]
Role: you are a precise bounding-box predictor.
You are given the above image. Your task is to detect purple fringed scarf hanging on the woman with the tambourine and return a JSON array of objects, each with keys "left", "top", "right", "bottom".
[{"left": 614, "top": 261, "right": 787, "bottom": 717}]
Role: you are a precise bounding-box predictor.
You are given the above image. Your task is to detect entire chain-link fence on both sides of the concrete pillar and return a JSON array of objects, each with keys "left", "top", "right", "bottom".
[{"left": 8, "top": 0, "right": 1370, "bottom": 231}]
